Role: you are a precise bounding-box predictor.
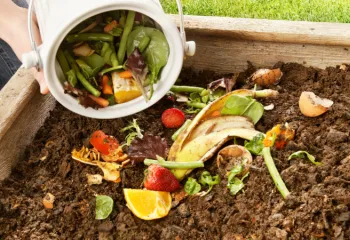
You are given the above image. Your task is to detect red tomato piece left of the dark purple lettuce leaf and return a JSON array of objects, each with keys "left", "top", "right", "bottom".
[{"left": 90, "top": 130, "right": 119, "bottom": 155}]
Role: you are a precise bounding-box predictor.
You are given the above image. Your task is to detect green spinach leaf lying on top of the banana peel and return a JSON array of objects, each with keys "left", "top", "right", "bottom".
[{"left": 221, "top": 95, "right": 264, "bottom": 124}]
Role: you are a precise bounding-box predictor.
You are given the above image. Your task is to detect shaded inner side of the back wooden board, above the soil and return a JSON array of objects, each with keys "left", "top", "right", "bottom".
[{"left": 184, "top": 34, "right": 350, "bottom": 73}]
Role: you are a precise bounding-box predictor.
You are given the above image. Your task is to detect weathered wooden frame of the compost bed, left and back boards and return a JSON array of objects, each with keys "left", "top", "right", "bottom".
[{"left": 0, "top": 15, "right": 350, "bottom": 180}]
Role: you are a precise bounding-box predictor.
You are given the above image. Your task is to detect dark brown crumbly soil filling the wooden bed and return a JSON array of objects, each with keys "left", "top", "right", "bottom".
[{"left": 0, "top": 63, "right": 350, "bottom": 240}]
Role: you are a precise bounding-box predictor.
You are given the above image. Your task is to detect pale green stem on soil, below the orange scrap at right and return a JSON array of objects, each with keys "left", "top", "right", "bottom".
[{"left": 262, "top": 147, "right": 290, "bottom": 198}]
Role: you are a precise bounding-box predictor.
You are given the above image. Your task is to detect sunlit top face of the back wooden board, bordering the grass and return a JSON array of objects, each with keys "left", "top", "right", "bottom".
[{"left": 170, "top": 15, "right": 350, "bottom": 46}]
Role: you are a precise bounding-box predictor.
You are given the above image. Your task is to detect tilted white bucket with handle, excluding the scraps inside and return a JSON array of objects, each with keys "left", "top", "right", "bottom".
[{"left": 23, "top": 0, "right": 195, "bottom": 119}]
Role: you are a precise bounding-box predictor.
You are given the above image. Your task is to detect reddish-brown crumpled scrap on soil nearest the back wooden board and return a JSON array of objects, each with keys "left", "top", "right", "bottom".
[{"left": 251, "top": 68, "right": 283, "bottom": 87}]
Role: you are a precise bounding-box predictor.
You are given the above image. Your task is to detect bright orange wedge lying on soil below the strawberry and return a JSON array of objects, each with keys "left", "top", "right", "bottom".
[{"left": 124, "top": 188, "right": 171, "bottom": 220}]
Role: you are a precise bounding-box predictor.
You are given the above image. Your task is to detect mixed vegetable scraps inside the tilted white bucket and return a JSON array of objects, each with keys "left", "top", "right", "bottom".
[{"left": 57, "top": 10, "right": 169, "bottom": 109}]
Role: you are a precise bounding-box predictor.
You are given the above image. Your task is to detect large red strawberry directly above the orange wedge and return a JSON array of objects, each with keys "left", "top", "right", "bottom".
[{"left": 143, "top": 164, "right": 180, "bottom": 192}]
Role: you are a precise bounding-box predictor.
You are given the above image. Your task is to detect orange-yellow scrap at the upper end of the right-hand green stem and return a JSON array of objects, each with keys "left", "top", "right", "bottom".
[{"left": 263, "top": 123, "right": 295, "bottom": 150}]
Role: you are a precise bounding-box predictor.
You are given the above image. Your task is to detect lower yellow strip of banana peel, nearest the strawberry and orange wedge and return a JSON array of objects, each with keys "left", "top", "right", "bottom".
[{"left": 173, "top": 128, "right": 261, "bottom": 180}]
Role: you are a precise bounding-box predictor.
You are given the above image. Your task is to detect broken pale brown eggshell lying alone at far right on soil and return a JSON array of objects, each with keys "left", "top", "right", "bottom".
[{"left": 299, "top": 92, "right": 333, "bottom": 117}]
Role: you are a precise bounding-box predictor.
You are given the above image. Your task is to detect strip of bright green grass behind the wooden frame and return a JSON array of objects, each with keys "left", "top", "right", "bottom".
[{"left": 161, "top": 0, "right": 350, "bottom": 24}]
